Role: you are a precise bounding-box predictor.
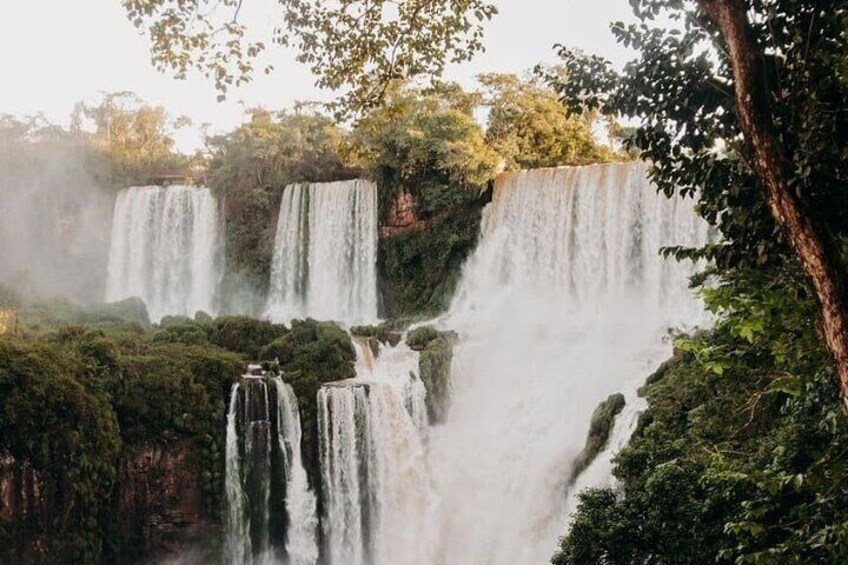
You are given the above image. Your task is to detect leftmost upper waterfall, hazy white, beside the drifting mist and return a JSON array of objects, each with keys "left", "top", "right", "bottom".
[{"left": 106, "top": 186, "right": 219, "bottom": 320}]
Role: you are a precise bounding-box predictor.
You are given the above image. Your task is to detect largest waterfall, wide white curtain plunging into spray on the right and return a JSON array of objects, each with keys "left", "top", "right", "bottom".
[{"left": 429, "top": 164, "right": 708, "bottom": 565}]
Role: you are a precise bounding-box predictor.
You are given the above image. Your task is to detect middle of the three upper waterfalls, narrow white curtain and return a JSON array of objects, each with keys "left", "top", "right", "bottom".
[{"left": 267, "top": 180, "right": 377, "bottom": 322}]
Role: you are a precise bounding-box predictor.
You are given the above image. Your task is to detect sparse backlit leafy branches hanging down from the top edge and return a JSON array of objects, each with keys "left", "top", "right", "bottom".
[{"left": 123, "top": 0, "right": 497, "bottom": 111}]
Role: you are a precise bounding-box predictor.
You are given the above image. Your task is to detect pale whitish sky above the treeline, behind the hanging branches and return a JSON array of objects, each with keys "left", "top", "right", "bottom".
[{"left": 0, "top": 0, "right": 632, "bottom": 150}]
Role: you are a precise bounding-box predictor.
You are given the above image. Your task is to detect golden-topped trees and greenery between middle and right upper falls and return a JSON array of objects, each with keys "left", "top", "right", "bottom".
[{"left": 351, "top": 85, "right": 498, "bottom": 317}]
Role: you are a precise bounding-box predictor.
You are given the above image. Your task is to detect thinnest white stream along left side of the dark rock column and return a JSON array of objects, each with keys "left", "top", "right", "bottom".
[{"left": 224, "top": 384, "right": 252, "bottom": 565}]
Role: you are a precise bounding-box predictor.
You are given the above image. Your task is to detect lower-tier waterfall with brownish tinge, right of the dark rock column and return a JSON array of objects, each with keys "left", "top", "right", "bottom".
[{"left": 318, "top": 345, "right": 436, "bottom": 565}]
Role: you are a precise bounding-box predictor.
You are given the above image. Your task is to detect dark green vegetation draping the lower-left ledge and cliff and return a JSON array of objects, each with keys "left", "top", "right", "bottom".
[{"left": 0, "top": 326, "right": 244, "bottom": 563}]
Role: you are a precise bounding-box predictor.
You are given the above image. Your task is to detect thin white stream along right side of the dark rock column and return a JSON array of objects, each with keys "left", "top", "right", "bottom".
[{"left": 274, "top": 377, "right": 318, "bottom": 565}]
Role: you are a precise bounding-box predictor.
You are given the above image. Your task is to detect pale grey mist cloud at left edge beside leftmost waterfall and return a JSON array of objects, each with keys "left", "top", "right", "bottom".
[{"left": 0, "top": 124, "right": 112, "bottom": 303}]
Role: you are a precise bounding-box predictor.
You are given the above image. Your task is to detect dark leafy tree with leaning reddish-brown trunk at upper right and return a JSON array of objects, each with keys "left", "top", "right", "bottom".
[{"left": 549, "top": 0, "right": 848, "bottom": 408}]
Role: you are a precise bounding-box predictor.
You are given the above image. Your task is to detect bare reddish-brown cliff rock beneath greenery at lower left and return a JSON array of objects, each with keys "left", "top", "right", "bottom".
[{"left": 0, "top": 439, "right": 221, "bottom": 563}]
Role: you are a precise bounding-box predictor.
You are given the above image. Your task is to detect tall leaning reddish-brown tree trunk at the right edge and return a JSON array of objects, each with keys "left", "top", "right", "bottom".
[{"left": 698, "top": 0, "right": 848, "bottom": 410}]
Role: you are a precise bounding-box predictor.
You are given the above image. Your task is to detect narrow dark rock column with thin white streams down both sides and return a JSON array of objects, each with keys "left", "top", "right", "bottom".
[{"left": 225, "top": 373, "right": 318, "bottom": 565}]
